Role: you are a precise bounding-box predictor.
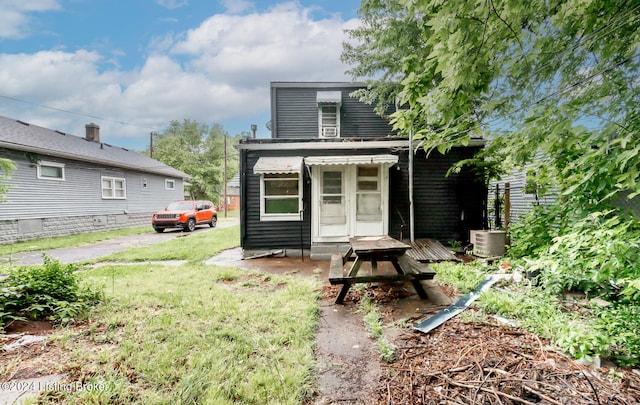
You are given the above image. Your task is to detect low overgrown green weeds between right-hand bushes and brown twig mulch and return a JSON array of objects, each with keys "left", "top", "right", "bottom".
[{"left": 432, "top": 262, "right": 640, "bottom": 366}]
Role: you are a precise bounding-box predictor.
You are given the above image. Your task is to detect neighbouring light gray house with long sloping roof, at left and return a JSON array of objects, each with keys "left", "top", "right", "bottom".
[{"left": 0, "top": 117, "right": 189, "bottom": 243}]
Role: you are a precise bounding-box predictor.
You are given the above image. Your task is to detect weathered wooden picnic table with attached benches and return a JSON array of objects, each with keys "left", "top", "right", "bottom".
[{"left": 329, "top": 235, "right": 435, "bottom": 304}]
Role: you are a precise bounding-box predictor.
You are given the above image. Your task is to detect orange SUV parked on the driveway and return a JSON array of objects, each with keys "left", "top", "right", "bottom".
[{"left": 151, "top": 200, "right": 218, "bottom": 232}]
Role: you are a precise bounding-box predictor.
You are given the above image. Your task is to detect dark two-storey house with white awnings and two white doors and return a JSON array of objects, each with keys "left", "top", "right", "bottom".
[{"left": 239, "top": 82, "right": 486, "bottom": 258}]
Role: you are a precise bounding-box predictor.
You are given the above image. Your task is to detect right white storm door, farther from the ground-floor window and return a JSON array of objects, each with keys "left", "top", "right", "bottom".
[{"left": 353, "top": 165, "right": 387, "bottom": 236}]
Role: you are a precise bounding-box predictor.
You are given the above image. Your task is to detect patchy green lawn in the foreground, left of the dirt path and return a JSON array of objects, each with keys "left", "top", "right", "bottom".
[{"left": 18, "top": 226, "right": 321, "bottom": 404}]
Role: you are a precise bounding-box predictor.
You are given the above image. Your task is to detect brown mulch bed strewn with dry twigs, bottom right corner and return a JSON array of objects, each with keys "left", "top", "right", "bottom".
[{"left": 325, "top": 288, "right": 640, "bottom": 405}]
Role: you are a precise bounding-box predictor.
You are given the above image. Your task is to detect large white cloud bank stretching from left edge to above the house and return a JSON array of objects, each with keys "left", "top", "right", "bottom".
[{"left": 0, "top": 0, "right": 356, "bottom": 149}]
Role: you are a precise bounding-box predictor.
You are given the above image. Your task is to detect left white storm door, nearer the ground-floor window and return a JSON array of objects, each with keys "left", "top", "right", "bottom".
[{"left": 318, "top": 166, "right": 349, "bottom": 238}]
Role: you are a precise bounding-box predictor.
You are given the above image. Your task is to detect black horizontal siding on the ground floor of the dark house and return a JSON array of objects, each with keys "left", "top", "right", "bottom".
[{"left": 240, "top": 144, "right": 486, "bottom": 250}]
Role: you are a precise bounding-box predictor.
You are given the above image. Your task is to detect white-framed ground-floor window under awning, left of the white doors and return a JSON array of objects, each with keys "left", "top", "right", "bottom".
[{"left": 260, "top": 173, "right": 302, "bottom": 221}]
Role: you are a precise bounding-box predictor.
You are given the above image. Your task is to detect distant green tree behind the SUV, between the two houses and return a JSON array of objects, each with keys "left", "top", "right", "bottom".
[{"left": 153, "top": 119, "right": 239, "bottom": 202}]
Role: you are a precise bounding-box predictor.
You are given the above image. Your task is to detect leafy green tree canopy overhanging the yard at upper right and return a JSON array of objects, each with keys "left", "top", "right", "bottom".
[{"left": 343, "top": 0, "right": 640, "bottom": 213}]
